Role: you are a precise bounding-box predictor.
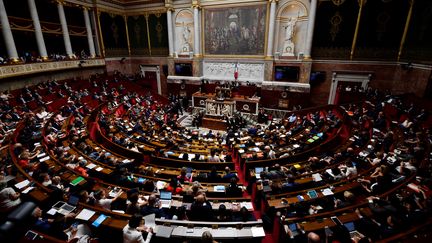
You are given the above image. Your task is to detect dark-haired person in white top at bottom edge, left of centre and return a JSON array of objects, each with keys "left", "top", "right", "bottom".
[{"left": 123, "top": 214, "right": 153, "bottom": 243}]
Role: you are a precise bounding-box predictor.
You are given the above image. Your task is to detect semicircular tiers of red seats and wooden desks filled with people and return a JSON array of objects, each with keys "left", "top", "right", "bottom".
[{"left": 0, "top": 77, "right": 431, "bottom": 242}]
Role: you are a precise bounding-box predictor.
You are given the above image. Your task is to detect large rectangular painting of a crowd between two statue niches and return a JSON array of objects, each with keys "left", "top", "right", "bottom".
[{"left": 204, "top": 4, "right": 267, "bottom": 55}]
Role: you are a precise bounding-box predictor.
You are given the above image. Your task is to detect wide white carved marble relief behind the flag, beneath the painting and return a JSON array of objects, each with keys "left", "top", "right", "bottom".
[{"left": 203, "top": 62, "right": 264, "bottom": 81}]
